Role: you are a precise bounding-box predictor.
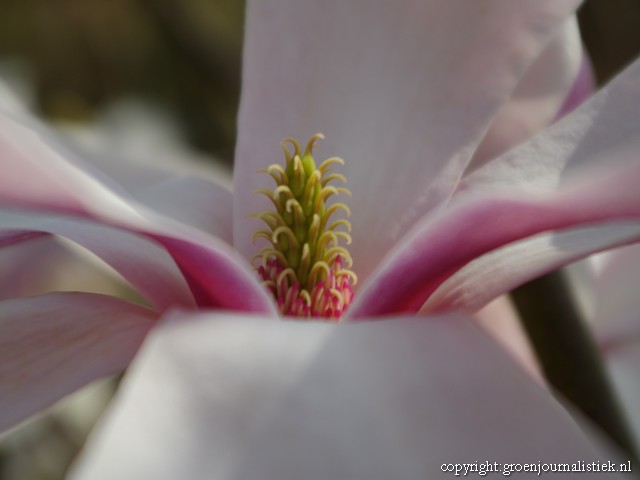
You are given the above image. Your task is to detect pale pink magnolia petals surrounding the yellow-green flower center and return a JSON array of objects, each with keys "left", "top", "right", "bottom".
[{"left": 0, "top": 0, "right": 640, "bottom": 479}]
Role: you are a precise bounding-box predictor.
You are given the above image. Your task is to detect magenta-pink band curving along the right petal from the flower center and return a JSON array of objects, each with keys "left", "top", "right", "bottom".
[{"left": 347, "top": 164, "right": 640, "bottom": 319}]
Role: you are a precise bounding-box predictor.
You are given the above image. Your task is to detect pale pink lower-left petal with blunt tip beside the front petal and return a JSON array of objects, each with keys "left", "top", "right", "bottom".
[{"left": 0, "top": 293, "right": 155, "bottom": 430}]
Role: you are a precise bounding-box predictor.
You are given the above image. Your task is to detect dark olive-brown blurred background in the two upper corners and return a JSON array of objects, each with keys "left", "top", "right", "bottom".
[{"left": 0, "top": 0, "right": 640, "bottom": 162}]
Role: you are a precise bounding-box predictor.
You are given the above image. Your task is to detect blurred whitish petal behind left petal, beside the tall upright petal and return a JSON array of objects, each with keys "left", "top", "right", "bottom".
[{"left": 63, "top": 114, "right": 232, "bottom": 243}]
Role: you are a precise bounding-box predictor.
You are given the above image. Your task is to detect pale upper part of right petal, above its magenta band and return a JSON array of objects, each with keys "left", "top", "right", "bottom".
[{"left": 453, "top": 55, "right": 640, "bottom": 199}]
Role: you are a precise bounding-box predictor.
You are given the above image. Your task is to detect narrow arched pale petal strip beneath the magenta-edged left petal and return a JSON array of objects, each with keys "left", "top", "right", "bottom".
[{"left": 0, "top": 212, "right": 195, "bottom": 311}]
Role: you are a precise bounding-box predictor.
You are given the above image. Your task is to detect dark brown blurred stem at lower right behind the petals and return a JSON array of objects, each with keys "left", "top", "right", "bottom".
[{"left": 512, "top": 270, "right": 638, "bottom": 465}]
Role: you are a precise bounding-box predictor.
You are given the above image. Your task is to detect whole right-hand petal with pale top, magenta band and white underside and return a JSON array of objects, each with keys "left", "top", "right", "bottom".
[{"left": 351, "top": 55, "right": 640, "bottom": 316}]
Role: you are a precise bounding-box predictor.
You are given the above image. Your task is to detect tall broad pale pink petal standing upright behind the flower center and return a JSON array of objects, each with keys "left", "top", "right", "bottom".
[{"left": 234, "top": 0, "right": 579, "bottom": 279}]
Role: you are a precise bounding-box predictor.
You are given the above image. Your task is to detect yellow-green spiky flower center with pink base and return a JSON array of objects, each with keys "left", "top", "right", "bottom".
[{"left": 252, "top": 133, "right": 357, "bottom": 320}]
